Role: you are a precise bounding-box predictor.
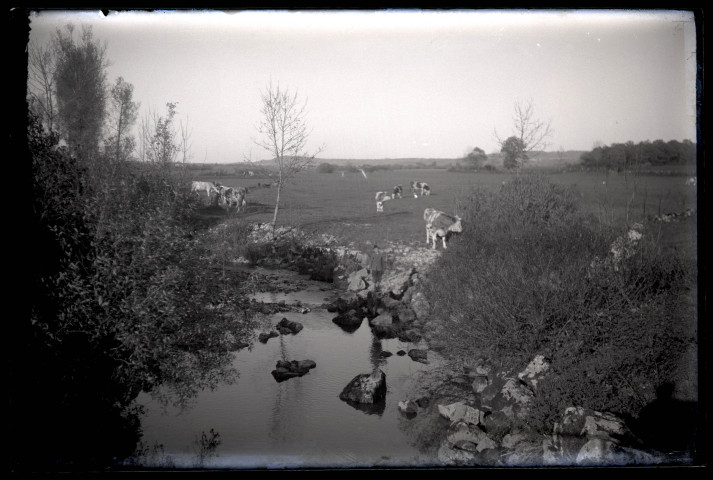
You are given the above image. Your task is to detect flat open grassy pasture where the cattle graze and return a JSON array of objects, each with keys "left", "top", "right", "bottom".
[{"left": 195, "top": 169, "right": 697, "bottom": 255}]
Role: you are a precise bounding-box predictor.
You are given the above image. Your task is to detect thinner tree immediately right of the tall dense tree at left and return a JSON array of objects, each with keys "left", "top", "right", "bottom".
[{"left": 106, "top": 77, "right": 139, "bottom": 161}]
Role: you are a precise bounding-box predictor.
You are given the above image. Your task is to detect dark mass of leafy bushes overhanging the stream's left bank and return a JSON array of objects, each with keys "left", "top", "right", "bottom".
[{"left": 18, "top": 111, "right": 251, "bottom": 465}]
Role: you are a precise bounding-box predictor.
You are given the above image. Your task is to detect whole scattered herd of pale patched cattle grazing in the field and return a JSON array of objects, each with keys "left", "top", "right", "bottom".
[{"left": 191, "top": 181, "right": 463, "bottom": 249}]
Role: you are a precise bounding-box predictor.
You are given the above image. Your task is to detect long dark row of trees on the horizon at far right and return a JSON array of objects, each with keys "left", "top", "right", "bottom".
[{"left": 580, "top": 140, "right": 696, "bottom": 171}]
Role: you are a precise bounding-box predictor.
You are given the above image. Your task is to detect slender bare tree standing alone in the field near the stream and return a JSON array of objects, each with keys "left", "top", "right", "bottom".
[{"left": 255, "top": 82, "right": 324, "bottom": 227}]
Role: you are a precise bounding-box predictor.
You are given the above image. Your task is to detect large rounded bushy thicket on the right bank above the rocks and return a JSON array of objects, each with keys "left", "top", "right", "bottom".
[{"left": 424, "top": 175, "right": 690, "bottom": 431}]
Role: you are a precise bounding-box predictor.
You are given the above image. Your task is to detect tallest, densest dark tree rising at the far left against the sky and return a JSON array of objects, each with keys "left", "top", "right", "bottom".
[{"left": 53, "top": 24, "right": 108, "bottom": 158}]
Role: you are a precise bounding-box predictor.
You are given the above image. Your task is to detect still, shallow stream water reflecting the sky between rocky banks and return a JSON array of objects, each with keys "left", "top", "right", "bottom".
[{"left": 131, "top": 269, "right": 436, "bottom": 469}]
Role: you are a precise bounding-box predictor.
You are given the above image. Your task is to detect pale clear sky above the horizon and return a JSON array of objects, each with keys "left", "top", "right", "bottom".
[{"left": 30, "top": 10, "right": 697, "bottom": 163}]
